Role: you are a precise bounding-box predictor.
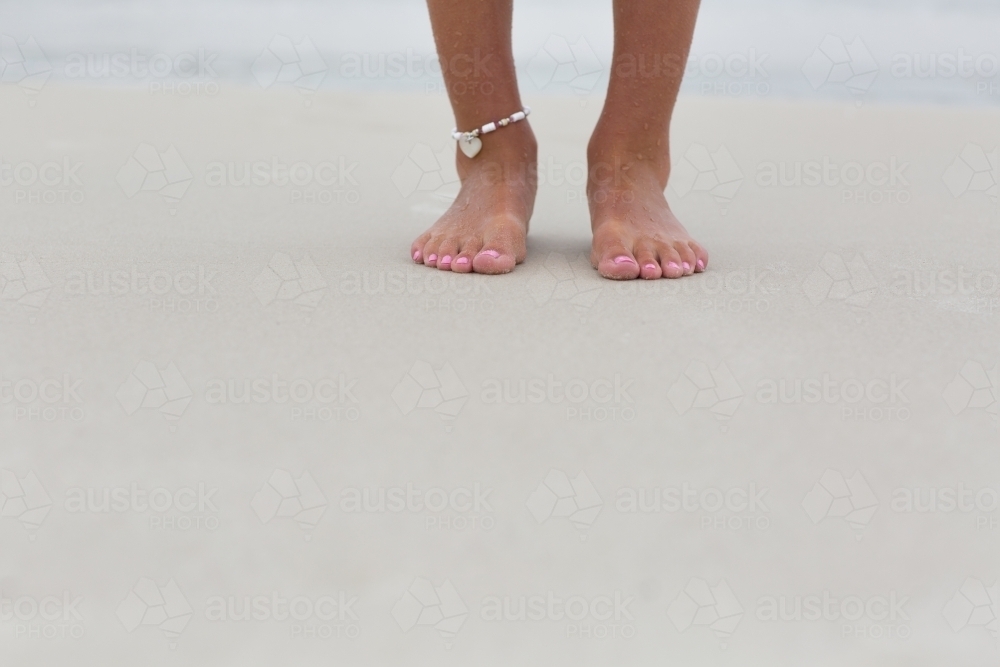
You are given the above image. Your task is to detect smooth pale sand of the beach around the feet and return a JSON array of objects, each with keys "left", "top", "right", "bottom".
[{"left": 0, "top": 85, "right": 1000, "bottom": 667}]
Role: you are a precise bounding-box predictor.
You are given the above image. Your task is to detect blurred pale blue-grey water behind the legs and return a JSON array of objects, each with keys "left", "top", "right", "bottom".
[{"left": 0, "top": 0, "right": 1000, "bottom": 106}]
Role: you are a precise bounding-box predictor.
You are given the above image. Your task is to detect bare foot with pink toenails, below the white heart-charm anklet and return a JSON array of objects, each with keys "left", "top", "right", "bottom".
[{"left": 410, "top": 122, "right": 537, "bottom": 273}]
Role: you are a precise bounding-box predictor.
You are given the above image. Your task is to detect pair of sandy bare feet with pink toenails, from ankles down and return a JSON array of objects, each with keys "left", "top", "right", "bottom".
[{"left": 410, "top": 122, "right": 708, "bottom": 280}]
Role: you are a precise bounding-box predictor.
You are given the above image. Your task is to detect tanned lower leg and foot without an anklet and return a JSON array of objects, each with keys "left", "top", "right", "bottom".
[{"left": 587, "top": 0, "right": 708, "bottom": 279}]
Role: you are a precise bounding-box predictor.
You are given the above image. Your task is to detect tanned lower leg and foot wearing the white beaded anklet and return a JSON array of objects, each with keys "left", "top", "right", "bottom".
[{"left": 410, "top": 0, "right": 536, "bottom": 273}]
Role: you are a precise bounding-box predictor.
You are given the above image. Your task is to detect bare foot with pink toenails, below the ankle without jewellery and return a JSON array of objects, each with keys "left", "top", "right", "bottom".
[{"left": 587, "top": 151, "right": 708, "bottom": 280}]
